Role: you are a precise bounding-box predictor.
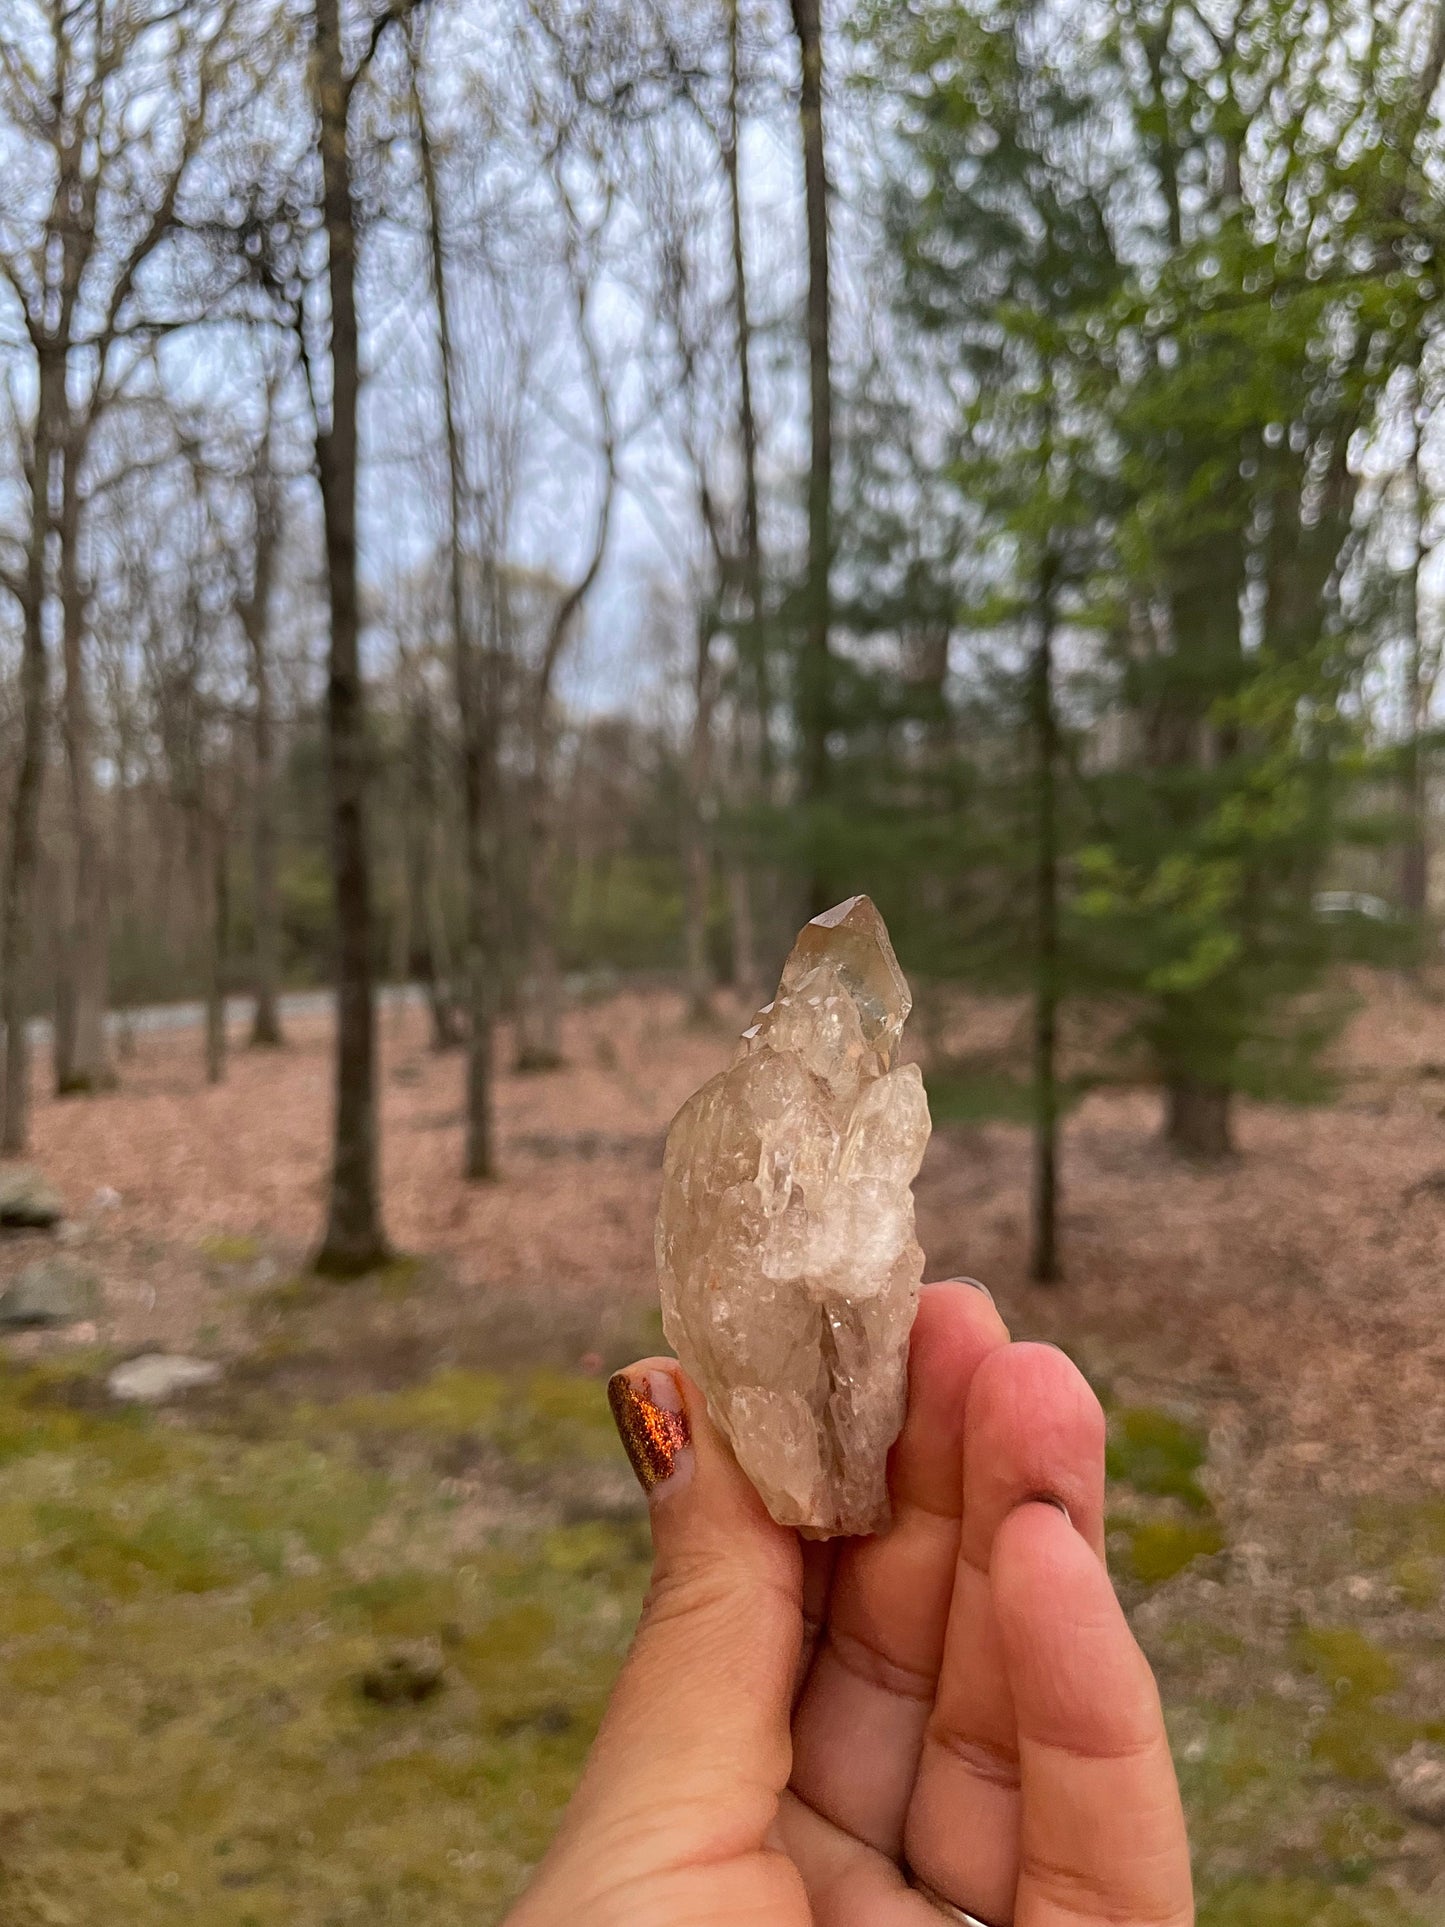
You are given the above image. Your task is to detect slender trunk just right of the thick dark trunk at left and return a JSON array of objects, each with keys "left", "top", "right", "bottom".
[{"left": 416, "top": 89, "right": 497, "bottom": 1183}]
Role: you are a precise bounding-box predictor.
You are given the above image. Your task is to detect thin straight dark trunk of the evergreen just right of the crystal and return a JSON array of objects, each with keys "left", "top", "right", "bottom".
[{"left": 1029, "top": 561, "right": 1060, "bottom": 1285}]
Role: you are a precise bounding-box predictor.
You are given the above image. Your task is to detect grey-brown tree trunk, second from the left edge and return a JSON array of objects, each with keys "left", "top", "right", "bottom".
[{"left": 56, "top": 441, "right": 116, "bottom": 1096}]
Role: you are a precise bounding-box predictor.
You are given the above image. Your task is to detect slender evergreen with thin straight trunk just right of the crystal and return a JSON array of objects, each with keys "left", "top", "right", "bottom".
[{"left": 870, "top": 4, "right": 1119, "bottom": 1281}]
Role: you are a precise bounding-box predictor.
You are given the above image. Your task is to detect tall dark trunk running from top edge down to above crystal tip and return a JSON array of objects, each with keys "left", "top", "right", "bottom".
[{"left": 792, "top": 0, "right": 834, "bottom": 911}]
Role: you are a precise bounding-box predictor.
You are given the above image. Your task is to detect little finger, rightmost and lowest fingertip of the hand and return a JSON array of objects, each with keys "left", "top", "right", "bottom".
[{"left": 990, "top": 1505, "right": 1195, "bottom": 1927}]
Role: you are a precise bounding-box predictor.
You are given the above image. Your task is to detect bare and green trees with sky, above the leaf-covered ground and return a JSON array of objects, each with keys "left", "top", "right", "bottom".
[{"left": 0, "top": 0, "right": 1445, "bottom": 1276}]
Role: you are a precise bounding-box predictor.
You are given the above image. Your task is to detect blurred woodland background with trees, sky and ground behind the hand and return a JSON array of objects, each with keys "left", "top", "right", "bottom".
[{"left": 0, "top": 0, "right": 1445, "bottom": 1927}]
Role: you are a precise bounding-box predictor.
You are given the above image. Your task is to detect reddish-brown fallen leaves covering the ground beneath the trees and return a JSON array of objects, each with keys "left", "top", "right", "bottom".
[{"left": 0, "top": 979, "right": 1445, "bottom": 1495}]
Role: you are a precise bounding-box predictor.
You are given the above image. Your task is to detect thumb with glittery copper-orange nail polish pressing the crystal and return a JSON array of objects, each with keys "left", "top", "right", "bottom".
[{"left": 520, "top": 1359, "right": 803, "bottom": 1881}]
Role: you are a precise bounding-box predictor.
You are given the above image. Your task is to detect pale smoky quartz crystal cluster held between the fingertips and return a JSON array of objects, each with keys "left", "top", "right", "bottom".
[{"left": 657, "top": 896, "right": 929, "bottom": 1538}]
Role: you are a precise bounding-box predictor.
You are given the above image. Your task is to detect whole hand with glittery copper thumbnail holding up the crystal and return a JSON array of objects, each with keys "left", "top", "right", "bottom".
[{"left": 509, "top": 1281, "right": 1195, "bottom": 1927}]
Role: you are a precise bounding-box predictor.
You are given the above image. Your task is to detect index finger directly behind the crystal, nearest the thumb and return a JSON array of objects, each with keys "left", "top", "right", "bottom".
[{"left": 792, "top": 1281, "right": 1008, "bottom": 1858}]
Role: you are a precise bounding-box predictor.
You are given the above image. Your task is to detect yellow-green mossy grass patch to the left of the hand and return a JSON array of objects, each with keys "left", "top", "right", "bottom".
[{"left": 0, "top": 1372, "right": 645, "bottom": 1927}]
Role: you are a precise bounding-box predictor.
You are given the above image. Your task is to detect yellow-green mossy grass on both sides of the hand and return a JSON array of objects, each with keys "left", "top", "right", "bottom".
[{"left": 0, "top": 1366, "right": 1435, "bottom": 1927}]
